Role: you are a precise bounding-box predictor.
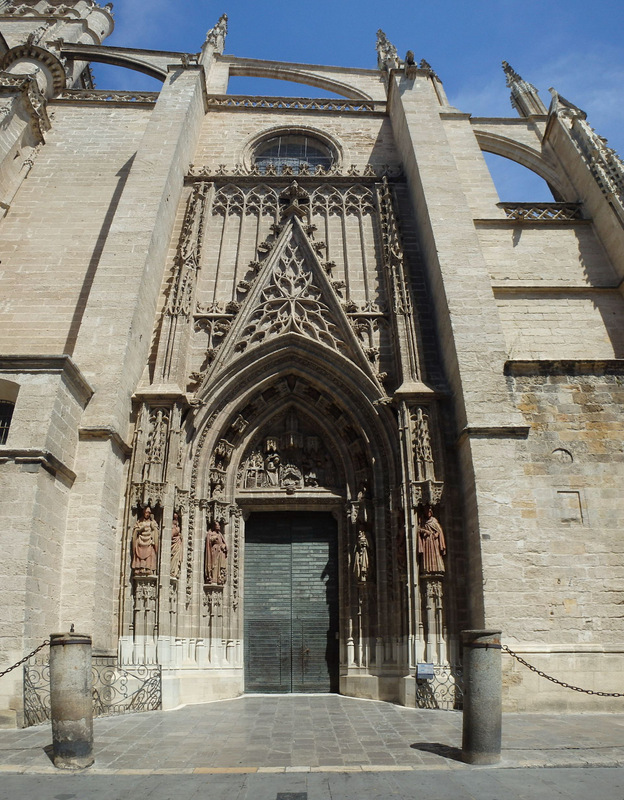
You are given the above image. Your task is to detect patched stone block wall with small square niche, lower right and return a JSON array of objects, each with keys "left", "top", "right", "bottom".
[{"left": 477, "top": 362, "right": 624, "bottom": 710}]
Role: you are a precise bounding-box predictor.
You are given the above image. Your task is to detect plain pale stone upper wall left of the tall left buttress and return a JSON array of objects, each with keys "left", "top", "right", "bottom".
[{"left": 0, "top": 103, "right": 150, "bottom": 354}]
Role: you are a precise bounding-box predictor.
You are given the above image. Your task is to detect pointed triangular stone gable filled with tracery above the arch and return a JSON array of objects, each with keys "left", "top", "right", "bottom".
[{"left": 197, "top": 216, "right": 383, "bottom": 391}]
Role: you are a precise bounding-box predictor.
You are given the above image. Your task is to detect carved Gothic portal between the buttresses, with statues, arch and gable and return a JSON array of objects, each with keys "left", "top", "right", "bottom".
[{"left": 121, "top": 176, "right": 460, "bottom": 704}]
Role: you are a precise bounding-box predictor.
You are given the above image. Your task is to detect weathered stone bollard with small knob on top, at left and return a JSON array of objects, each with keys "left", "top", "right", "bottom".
[{"left": 50, "top": 626, "right": 93, "bottom": 769}]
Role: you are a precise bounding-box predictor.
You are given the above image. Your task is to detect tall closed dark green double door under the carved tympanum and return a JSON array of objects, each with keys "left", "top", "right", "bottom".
[{"left": 245, "top": 512, "right": 338, "bottom": 692}]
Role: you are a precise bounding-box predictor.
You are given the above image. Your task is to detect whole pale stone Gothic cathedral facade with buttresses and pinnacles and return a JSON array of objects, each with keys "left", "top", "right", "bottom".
[{"left": 0, "top": 0, "right": 624, "bottom": 722}]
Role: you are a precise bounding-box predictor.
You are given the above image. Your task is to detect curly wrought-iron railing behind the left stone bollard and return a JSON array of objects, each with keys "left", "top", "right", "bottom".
[{"left": 24, "top": 656, "right": 162, "bottom": 728}]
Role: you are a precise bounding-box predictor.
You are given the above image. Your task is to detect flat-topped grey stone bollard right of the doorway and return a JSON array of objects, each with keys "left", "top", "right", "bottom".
[{"left": 462, "top": 631, "right": 502, "bottom": 764}]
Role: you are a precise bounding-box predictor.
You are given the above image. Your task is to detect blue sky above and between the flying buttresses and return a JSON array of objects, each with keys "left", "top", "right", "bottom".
[{"left": 94, "top": 0, "right": 624, "bottom": 200}]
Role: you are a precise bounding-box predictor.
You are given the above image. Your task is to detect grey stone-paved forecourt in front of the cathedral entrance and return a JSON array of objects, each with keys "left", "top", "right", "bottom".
[{"left": 0, "top": 695, "right": 624, "bottom": 775}]
